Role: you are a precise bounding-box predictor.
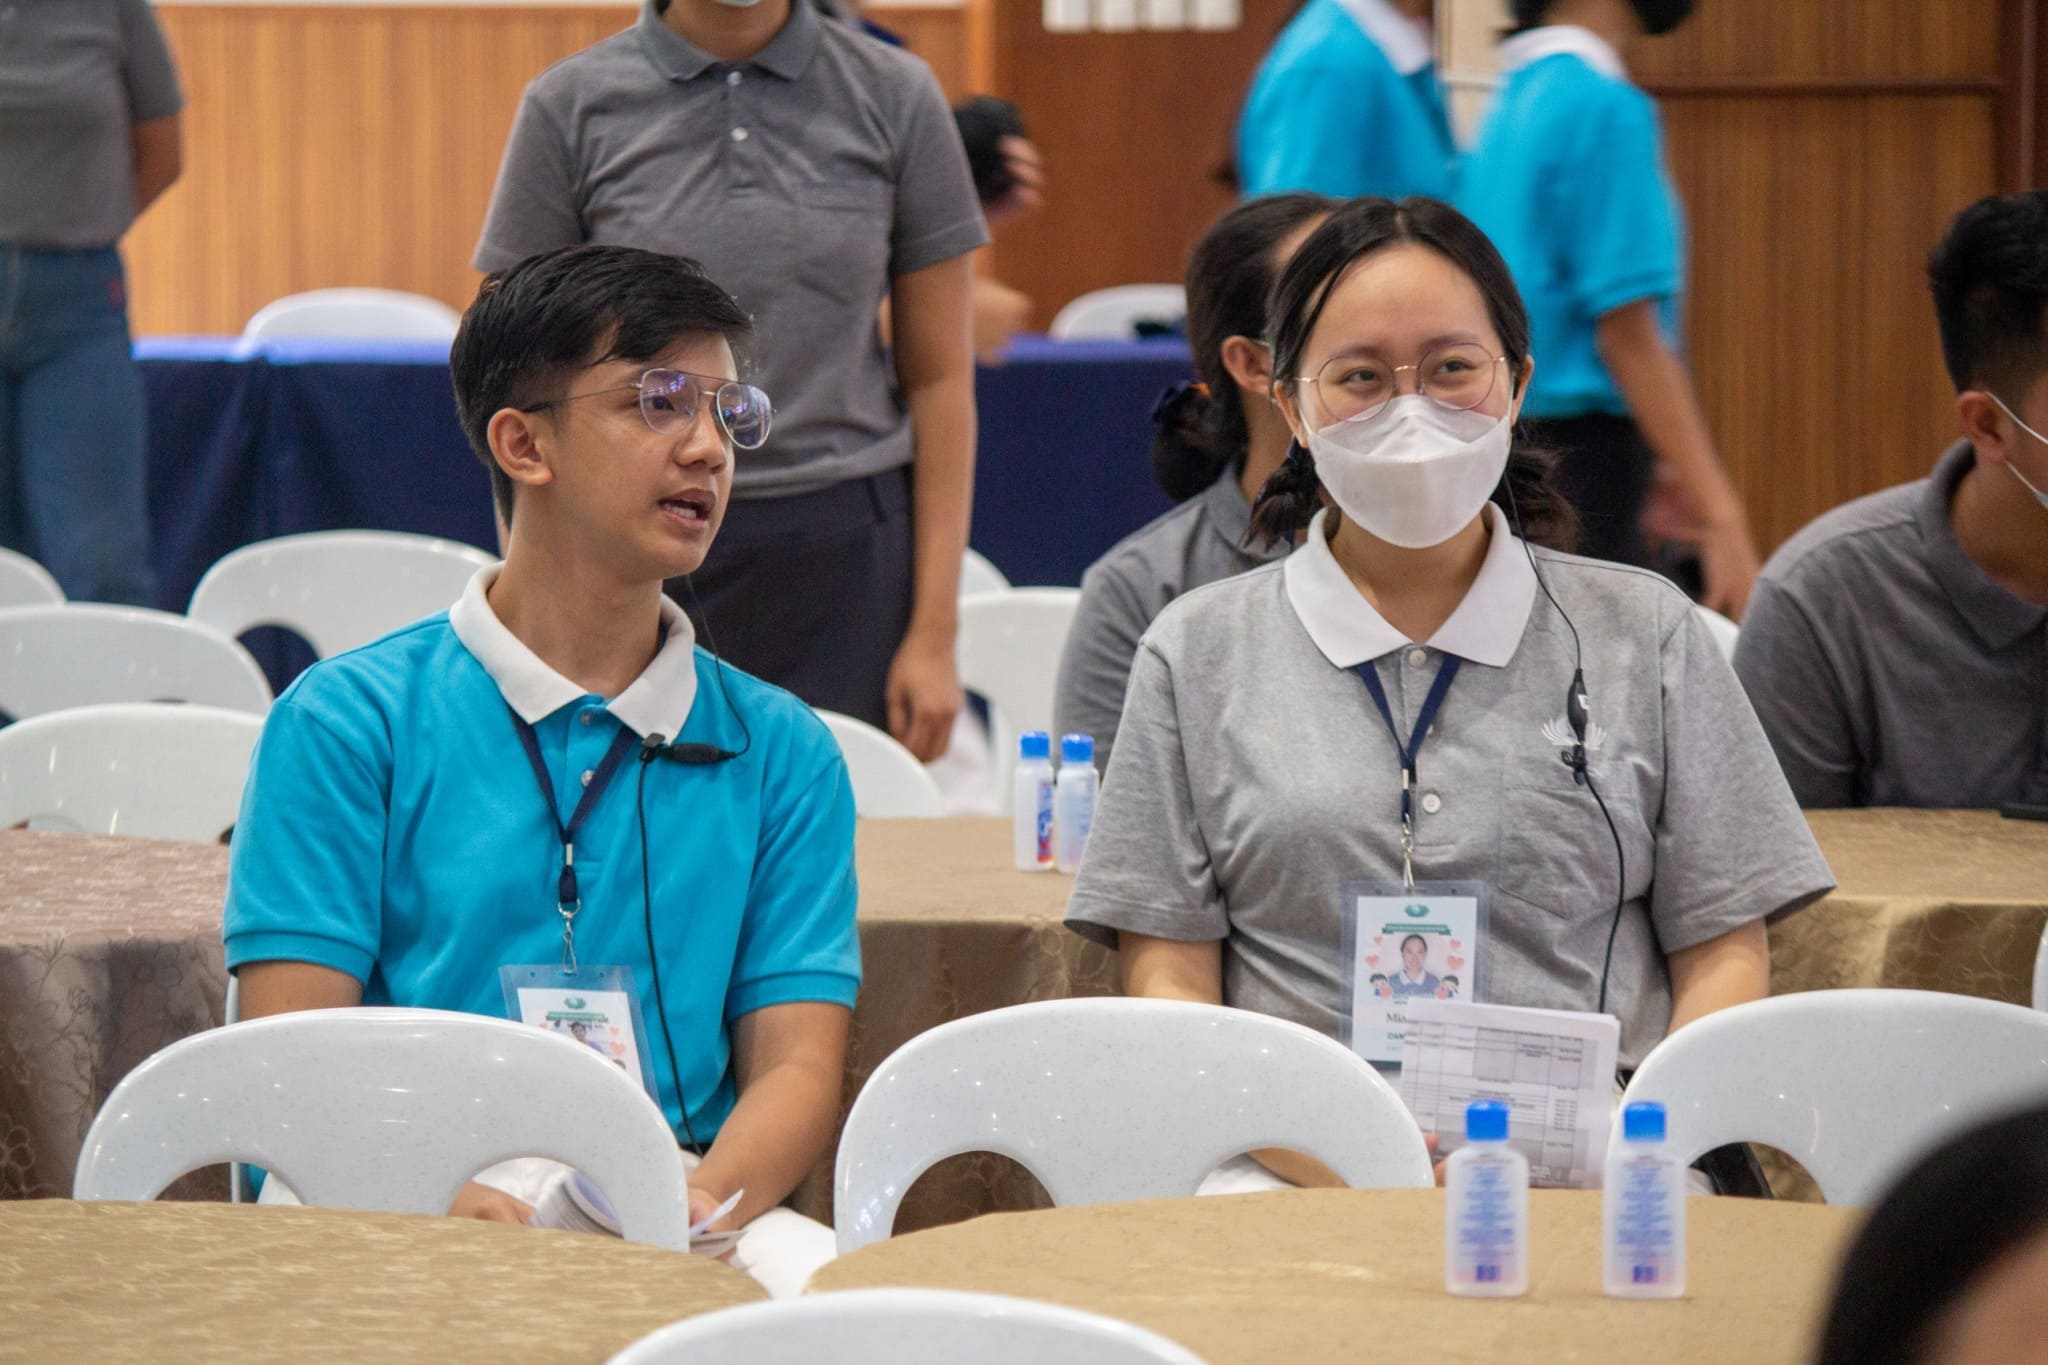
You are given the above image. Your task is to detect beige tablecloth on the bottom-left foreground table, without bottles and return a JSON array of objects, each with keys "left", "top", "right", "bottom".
[{"left": 0, "top": 1199, "right": 766, "bottom": 1365}]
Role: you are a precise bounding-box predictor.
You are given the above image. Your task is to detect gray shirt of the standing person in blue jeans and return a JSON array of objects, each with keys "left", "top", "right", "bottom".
[{"left": 0, "top": 0, "right": 184, "bottom": 248}]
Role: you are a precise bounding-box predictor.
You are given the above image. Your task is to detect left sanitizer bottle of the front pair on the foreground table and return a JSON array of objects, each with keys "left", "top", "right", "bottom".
[{"left": 1444, "top": 1099, "right": 1530, "bottom": 1300}]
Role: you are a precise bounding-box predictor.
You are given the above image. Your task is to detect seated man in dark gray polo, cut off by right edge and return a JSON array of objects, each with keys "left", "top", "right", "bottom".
[{"left": 1735, "top": 190, "right": 2048, "bottom": 806}]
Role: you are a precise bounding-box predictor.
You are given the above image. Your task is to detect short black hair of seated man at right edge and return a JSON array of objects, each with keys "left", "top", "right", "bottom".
[{"left": 1927, "top": 190, "right": 2048, "bottom": 403}]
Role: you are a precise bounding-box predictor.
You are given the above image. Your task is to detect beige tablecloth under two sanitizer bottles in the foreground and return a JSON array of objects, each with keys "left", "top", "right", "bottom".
[{"left": 811, "top": 1189, "right": 1858, "bottom": 1365}]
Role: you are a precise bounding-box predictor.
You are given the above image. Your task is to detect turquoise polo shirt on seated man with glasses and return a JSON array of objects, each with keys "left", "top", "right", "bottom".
[{"left": 223, "top": 569, "right": 860, "bottom": 1142}]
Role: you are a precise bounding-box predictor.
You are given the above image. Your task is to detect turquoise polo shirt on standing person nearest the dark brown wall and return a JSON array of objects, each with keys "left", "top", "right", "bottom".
[{"left": 1458, "top": 25, "right": 1686, "bottom": 417}]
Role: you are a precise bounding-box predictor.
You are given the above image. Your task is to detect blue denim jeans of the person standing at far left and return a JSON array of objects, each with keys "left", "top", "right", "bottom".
[{"left": 0, "top": 244, "right": 158, "bottom": 606}]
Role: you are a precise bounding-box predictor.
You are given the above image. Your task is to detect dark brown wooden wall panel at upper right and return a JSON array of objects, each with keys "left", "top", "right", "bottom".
[{"left": 1632, "top": 0, "right": 2007, "bottom": 553}]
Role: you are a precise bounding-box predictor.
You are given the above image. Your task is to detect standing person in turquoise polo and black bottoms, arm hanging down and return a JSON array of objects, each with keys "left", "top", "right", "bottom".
[{"left": 1458, "top": 0, "right": 1757, "bottom": 618}]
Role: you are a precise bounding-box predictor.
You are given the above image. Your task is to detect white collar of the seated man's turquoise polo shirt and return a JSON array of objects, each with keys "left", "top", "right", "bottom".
[{"left": 449, "top": 565, "right": 696, "bottom": 739}]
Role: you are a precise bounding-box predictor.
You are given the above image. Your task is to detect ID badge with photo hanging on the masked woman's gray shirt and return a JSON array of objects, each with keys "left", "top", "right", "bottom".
[{"left": 1337, "top": 882, "right": 1489, "bottom": 1070}]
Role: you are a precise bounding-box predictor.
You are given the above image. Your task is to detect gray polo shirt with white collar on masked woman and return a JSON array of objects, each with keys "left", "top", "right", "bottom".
[{"left": 1067, "top": 510, "right": 1833, "bottom": 1064}]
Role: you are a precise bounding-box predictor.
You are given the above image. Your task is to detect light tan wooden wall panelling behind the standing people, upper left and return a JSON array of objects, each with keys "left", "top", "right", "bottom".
[{"left": 127, "top": 4, "right": 965, "bottom": 334}]
